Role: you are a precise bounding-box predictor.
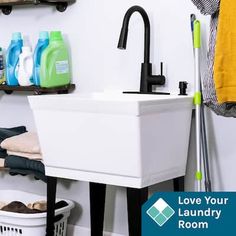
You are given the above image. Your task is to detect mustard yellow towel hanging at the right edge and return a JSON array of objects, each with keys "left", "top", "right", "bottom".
[{"left": 214, "top": 0, "right": 236, "bottom": 103}]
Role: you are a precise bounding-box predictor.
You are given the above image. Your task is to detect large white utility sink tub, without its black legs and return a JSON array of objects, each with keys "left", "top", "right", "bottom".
[{"left": 29, "top": 93, "right": 193, "bottom": 188}]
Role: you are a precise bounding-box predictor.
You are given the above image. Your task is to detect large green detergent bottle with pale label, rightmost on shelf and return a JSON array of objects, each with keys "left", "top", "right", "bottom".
[{"left": 40, "top": 31, "right": 71, "bottom": 88}]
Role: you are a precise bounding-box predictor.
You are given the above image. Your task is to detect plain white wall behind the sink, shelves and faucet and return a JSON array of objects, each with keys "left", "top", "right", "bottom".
[{"left": 0, "top": 0, "right": 236, "bottom": 235}]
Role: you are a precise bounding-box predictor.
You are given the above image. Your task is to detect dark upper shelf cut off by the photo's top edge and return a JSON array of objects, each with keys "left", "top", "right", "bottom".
[{"left": 0, "top": 0, "right": 76, "bottom": 15}]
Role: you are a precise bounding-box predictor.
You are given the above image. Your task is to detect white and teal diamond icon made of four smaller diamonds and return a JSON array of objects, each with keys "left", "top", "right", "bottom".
[{"left": 146, "top": 198, "right": 175, "bottom": 226}]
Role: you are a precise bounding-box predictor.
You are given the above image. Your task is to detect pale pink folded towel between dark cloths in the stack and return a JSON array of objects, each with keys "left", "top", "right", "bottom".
[{"left": 1, "top": 132, "right": 41, "bottom": 154}]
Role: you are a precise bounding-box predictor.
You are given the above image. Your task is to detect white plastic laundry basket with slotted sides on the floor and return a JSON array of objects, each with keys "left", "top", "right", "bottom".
[{"left": 0, "top": 190, "right": 74, "bottom": 236}]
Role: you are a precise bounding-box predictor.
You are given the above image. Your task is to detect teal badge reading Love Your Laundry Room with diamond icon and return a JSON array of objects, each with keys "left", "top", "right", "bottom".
[{"left": 141, "top": 192, "right": 236, "bottom": 236}]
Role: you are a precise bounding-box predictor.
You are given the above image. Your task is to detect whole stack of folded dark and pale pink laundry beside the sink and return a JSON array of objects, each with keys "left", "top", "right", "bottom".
[{"left": 0, "top": 126, "right": 46, "bottom": 181}]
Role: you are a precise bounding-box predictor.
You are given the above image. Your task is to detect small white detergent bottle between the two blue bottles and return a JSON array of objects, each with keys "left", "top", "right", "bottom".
[{"left": 17, "top": 46, "right": 33, "bottom": 86}]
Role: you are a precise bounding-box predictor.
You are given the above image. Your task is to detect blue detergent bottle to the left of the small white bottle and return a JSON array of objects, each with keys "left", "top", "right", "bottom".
[{"left": 6, "top": 32, "right": 23, "bottom": 86}]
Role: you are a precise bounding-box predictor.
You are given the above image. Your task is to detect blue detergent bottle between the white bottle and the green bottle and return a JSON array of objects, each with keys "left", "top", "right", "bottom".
[{"left": 33, "top": 31, "right": 49, "bottom": 86}]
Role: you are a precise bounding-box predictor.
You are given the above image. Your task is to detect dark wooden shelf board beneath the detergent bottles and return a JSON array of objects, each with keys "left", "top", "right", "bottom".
[{"left": 0, "top": 84, "right": 75, "bottom": 95}]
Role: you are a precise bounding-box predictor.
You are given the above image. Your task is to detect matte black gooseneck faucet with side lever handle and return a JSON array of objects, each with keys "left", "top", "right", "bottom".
[{"left": 118, "top": 6, "right": 165, "bottom": 93}]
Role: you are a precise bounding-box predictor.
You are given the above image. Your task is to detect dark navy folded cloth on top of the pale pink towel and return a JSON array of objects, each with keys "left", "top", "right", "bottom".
[{"left": 0, "top": 126, "right": 27, "bottom": 158}]
